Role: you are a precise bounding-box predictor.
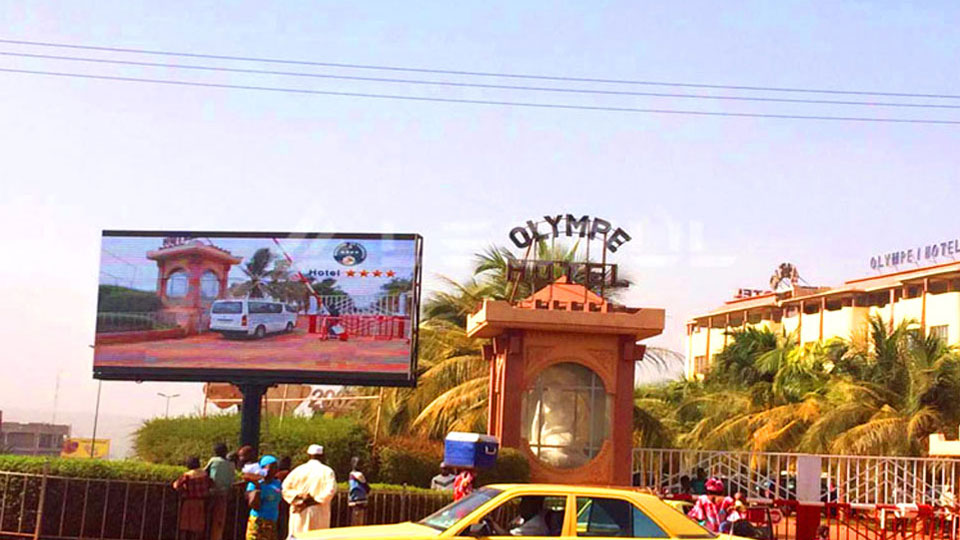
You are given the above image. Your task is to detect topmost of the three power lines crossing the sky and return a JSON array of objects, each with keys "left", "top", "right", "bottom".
[{"left": 0, "top": 39, "right": 960, "bottom": 99}]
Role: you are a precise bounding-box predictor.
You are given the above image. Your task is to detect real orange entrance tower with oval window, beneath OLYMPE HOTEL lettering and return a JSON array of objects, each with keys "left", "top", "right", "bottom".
[{"left": 467, "top": 277, "right": 664, "bottom": 485}]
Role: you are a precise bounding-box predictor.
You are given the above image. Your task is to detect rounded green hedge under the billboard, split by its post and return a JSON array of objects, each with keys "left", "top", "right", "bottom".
[{"left": 134, "top": 414, "right": 370, "bottom": 478}]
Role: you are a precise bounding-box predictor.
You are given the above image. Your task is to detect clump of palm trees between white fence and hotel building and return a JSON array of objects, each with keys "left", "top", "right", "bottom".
[{"left": 637, "top": 317, "right": 960, "bottom": 456}]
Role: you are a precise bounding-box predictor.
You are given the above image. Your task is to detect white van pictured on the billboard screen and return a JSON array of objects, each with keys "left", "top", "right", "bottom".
[{"left": 210, "top": 298, "right": 297, "bottom": 339}]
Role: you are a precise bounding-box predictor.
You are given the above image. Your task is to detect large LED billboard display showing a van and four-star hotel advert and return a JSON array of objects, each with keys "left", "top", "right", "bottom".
[{"left": 93, "top": 231, "right": 422, "bottom": 386}]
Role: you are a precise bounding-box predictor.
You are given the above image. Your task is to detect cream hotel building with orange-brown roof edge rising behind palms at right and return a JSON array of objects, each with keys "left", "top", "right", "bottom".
[{"left": 686, "top": 262, "right": 960, "bottom": 378}]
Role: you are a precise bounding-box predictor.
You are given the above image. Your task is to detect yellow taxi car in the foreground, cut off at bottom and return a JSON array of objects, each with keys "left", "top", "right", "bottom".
[{"left": 297, "top": 484, "right": 727, "bottom": 540}]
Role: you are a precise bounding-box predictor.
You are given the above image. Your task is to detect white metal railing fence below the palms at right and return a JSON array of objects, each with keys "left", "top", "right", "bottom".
[{"left": 633, "top": 448, "right": 960, "bottom": 505}]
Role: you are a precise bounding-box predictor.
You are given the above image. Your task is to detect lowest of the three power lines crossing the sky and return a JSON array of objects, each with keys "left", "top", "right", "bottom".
[{"left": 0, "top": 68, "right": 960, "bottom": 125}]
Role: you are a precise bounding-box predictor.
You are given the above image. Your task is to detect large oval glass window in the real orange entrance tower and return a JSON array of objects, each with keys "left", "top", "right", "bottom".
[{"left": 522, "top": 362, "right": 612, "bottom": 468}]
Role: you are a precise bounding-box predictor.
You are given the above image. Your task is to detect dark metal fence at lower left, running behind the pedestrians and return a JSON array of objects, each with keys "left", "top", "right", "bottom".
[{"left": 0, "top": 472, "right": 450, "bottom": 540}]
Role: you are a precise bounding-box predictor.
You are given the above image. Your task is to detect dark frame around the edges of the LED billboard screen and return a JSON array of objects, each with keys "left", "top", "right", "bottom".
[{"left": 93, "top": 230, "right": 423, "bottom": 387}]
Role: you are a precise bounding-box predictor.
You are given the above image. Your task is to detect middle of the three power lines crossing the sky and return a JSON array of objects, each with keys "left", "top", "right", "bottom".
[{"left": 0, "top": 51, "right": 960, "bottom": 109}]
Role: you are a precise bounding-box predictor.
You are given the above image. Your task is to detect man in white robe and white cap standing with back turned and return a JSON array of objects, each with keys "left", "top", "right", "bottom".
[{"left": 283, "top": 444, "right": 337, "bottom": 536}]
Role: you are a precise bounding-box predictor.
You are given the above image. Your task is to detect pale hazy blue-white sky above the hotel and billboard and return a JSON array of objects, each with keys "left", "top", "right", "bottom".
[{"left": 0, "top": 0, "right": 960, "bottom": 456}]
